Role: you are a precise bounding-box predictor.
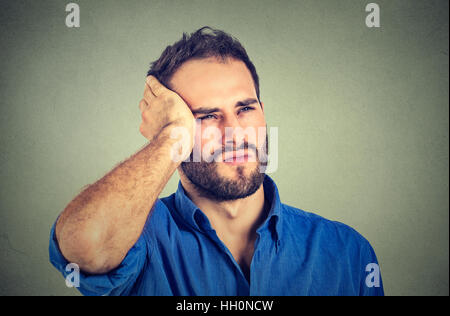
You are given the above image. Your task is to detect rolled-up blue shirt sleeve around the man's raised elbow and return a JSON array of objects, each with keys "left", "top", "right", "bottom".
[{"left": 49, "top": 222, "right": 148, "bottom": 296}]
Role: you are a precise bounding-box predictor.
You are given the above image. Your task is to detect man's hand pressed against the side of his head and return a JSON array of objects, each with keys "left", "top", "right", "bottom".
[{"left": 139, "top": 76, "right": 195, "bottom": 157}]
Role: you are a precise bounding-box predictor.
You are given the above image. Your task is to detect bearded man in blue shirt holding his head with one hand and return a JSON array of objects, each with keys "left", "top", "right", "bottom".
[{"left": 50, "top": 27, "right": 383, "bottom": 295}]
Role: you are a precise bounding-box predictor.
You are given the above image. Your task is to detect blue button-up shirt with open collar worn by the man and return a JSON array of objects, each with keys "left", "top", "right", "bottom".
[{"left": 49, "top": 176, "right": 383, "bottom": 296}]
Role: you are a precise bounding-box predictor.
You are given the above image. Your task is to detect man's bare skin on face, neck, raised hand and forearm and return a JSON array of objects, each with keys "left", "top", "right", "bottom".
[{"left": 55, "top": 58, "right": 268, "bottom": 278}]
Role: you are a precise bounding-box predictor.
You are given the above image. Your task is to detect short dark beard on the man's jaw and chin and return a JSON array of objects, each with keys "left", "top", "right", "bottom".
[{"left": 181, "top": 134, "right": 268, "bottom": 202}]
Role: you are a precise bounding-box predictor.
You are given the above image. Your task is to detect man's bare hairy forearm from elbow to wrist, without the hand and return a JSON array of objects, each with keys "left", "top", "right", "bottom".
[{"left": 55, "top": 134, "right": 179, "bottom": 273}]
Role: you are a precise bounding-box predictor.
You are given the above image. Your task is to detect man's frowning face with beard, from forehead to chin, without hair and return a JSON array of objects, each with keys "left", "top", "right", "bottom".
[{"left": 170, "top": 58, "right": 267, "bottom": 200}]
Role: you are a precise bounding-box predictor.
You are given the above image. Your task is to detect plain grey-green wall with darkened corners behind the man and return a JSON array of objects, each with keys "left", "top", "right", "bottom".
[{"left": 0, "top": 0, "right": 449, "bottom": 295}]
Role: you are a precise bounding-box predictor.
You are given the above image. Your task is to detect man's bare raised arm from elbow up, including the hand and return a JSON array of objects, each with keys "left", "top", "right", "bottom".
[{"left": 55, "top": 77, "right": 194, "bottom": 273}]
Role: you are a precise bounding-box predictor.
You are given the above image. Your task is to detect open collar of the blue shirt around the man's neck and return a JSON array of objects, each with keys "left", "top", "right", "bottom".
[{"left": 175, "top": 175, "right": 282, "bottom": 241}]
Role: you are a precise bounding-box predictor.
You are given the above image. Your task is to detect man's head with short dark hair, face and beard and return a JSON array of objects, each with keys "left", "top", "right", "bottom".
[{"left": 148, "top": 28, "right": 267, "bottom": 201}]
